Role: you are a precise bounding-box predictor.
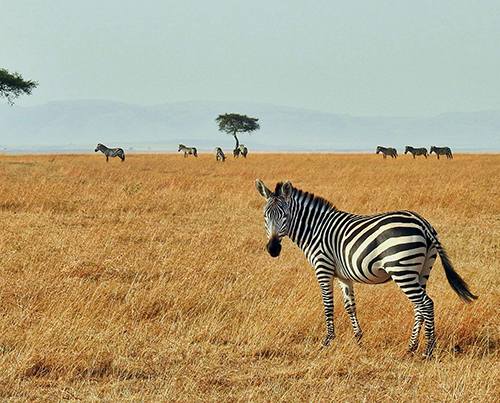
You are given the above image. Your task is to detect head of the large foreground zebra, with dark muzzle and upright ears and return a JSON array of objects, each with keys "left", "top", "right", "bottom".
[{"left": 255, "top": 179, "right": 292, "bottom": 257}]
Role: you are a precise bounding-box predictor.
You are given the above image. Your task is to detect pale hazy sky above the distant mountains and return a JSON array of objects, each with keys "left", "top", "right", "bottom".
[{"left": 0, "top": 0, "right": 500, "bottom": 116}]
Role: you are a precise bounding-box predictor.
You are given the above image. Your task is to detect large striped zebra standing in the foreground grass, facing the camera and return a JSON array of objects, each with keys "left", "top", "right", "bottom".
[{"left": 256, "top": 180, "right": 477, "bottom": 357}]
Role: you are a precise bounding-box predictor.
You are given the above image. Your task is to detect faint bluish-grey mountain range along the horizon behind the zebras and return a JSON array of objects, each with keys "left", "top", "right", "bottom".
[{"left": 0, "top": 100, "right": 500, "bottom": 152}]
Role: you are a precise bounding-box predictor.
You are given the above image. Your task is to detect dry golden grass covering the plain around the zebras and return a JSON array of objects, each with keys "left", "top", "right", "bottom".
[{"left": 0, "top": 154, "right": 500, "bottom": 402}]
